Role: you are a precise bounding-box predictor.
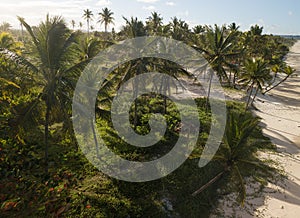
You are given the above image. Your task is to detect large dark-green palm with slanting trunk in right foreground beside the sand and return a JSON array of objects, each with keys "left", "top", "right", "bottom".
[{"left": 192, "top": 111, "right": 271, "bottom": 205}]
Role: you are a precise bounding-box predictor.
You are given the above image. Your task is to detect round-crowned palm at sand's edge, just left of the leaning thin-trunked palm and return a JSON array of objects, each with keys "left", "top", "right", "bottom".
[{"left": 240, "top": 58, "right": 272, "bottom": 110}]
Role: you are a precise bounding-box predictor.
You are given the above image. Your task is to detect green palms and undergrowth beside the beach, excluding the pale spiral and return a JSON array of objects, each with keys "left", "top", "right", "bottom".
[{"left": 0, "top": 8, "right": 294, "bottom": 217}]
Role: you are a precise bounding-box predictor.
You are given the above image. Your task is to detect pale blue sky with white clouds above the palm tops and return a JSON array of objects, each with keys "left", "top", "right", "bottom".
[{"left": 0, "top": 0, "right": 300, "bottom": 35}]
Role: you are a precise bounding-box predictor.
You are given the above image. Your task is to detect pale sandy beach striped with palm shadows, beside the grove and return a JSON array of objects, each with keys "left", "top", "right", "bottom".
[{"left": 212, "top": 41, "right": 300, "bottom": 218}]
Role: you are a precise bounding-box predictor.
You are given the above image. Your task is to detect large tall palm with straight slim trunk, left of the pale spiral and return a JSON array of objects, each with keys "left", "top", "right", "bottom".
[{"left": 3, "top": 15, "right": 86, "bottom": 173}]
